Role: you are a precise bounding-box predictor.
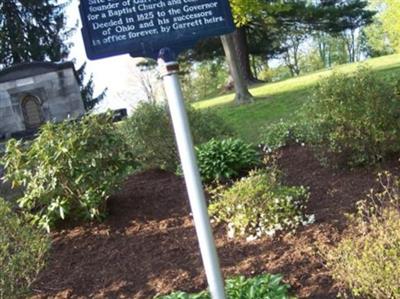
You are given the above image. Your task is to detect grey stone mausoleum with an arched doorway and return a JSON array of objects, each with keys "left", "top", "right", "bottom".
[{"left": 0, "top": 62, "right": 85, "bottom": 140}]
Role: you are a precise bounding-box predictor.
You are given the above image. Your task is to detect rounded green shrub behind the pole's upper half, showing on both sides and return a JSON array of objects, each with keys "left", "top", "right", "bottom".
[{"left": 122, "top": 103, "right": 232, "bottom": 171}]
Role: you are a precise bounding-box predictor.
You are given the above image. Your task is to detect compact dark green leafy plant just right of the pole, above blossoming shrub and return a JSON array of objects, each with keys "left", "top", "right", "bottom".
[{"left": 196, "top": 138, "right": 261, "bottom": 182}]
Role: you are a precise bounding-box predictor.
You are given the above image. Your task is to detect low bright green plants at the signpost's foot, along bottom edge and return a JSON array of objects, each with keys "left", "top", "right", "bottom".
[{"left": 156, "top": 274, "right": 294, "bottom": 299}]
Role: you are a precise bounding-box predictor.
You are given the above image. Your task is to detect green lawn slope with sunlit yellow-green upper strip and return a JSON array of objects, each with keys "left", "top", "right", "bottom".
[{"left": 194, "top": 55, "right": 400, "bottom": 142}]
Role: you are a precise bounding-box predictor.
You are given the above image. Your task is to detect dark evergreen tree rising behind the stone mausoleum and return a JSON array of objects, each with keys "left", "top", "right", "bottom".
[{"left": 0, "top": 0, "right": 72, "bottom": 67}]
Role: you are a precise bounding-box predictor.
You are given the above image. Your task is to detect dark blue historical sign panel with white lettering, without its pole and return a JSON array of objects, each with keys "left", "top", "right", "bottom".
[{"left": 80, "top": 0, "right": 235, "bottom": 59}]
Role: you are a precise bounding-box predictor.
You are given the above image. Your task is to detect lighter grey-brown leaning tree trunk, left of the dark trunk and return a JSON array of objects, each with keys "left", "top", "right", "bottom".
[{"left": 221, "top": 33, "right": 254, "bottom": 104}]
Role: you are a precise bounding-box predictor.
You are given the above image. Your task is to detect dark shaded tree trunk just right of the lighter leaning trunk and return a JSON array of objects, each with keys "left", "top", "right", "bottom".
[{"left": 232, "top": 27, "right": 260, "bottom": 84}]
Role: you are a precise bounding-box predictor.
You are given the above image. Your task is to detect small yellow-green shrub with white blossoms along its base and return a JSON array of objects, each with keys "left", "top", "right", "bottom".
[{"left": 209, "top": 170, "right": 312, "bottom": 240}]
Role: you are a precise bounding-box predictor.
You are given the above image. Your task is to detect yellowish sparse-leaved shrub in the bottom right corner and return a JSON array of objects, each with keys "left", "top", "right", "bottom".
[{"left": 322, "top": 174, "right": 400, "bottom": 299}]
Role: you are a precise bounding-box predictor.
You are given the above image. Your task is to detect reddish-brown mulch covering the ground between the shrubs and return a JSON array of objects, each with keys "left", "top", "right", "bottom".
[{"left": 33, "top": 146, "right": 399, "bottom": 298}]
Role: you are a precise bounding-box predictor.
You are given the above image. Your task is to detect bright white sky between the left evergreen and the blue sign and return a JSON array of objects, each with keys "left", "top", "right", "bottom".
[{"left": 66, "top": 0, "right": 144, "bottom": 110}]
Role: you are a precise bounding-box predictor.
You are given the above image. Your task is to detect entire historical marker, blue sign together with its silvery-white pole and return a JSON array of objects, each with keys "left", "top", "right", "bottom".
[{"left": 80, "top": 0, "right": 235, "bottom": 299}]
